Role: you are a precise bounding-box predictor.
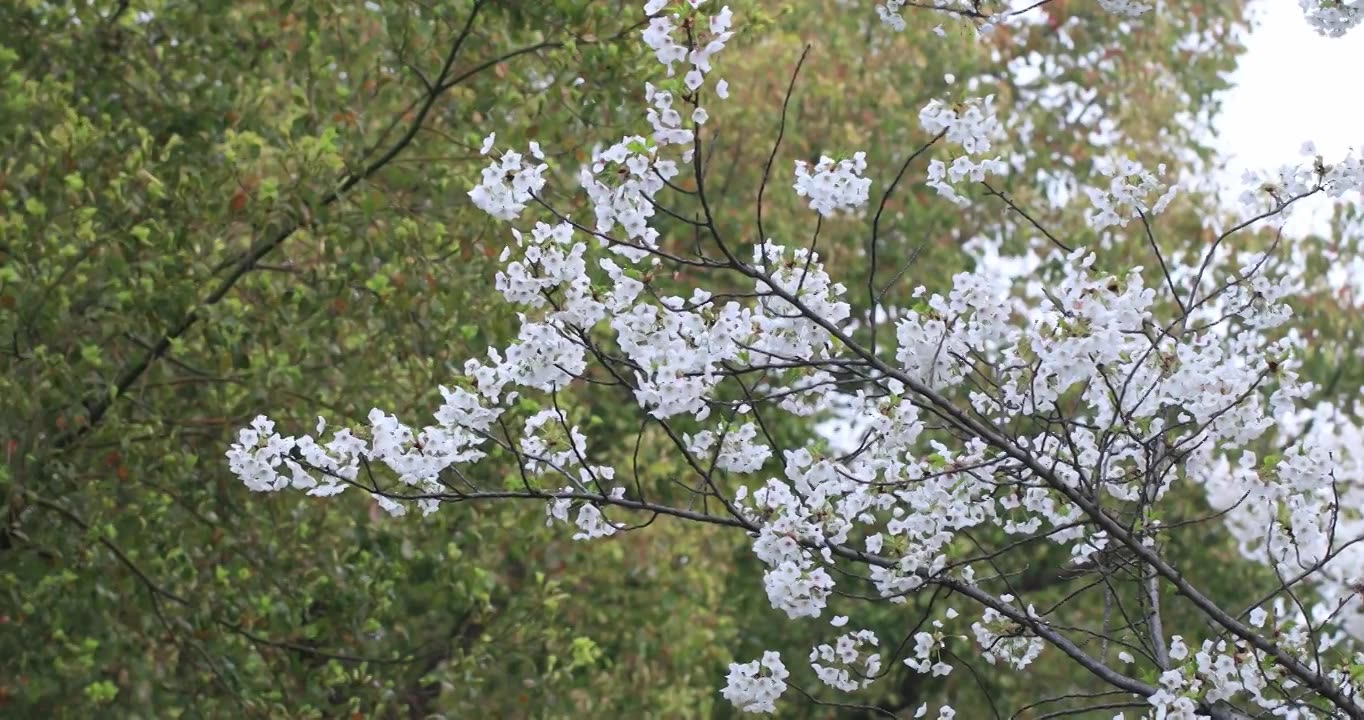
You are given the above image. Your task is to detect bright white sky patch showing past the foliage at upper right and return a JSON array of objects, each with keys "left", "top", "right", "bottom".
[{"left": 1214, "top": 0, "right": 1364, "bottom": 232}]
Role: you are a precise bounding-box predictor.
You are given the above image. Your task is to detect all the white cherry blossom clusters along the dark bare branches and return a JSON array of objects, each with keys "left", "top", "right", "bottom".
[{"left": 228, "top": 0, "right": 1364, "bottom": 719}]
